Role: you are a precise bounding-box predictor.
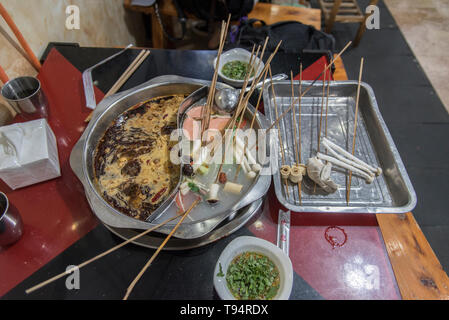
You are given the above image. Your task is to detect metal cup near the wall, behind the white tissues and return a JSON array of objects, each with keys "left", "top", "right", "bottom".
[{"left": 1, "top": 77, "right": 48, "bottom": 118}]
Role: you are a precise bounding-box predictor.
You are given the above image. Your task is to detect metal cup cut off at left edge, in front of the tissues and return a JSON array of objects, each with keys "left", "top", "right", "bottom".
[{"left": 0, "top": 192, "right": 23, "bottom": 247}]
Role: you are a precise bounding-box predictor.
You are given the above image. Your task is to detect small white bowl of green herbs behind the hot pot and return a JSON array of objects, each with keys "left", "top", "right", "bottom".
[{"left": 214, "top": 48, "right": 265, "bottom": 88}]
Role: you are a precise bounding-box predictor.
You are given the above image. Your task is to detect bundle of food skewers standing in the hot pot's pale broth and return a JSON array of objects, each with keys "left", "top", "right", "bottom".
[{"left": 179, "top": 23, "right": 281, "bottom": 206}]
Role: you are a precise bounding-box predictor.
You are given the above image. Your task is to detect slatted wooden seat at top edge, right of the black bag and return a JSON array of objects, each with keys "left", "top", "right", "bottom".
[{"left": 318, "top": 0, "right": 379, "bottom": 46}]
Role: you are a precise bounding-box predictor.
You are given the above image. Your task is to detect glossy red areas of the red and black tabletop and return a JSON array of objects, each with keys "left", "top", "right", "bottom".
[{"left": 0, "top": 49, "right": 400, "bottom": 299}]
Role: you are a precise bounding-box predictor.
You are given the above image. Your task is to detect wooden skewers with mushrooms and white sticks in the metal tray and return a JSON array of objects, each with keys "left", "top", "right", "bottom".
[{"left": 271, "top": 50, "right": 382, "bottom": 204}]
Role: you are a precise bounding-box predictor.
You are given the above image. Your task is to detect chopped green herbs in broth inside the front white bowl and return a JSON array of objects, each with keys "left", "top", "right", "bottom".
[{"left": 226, "top": 252, "right": 280, "bottom": 300}]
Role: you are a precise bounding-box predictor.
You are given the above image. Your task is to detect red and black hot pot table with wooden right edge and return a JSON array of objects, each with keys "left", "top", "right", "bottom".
[{"left": 0, "top": 44, "right": 449, "bottom": 300}]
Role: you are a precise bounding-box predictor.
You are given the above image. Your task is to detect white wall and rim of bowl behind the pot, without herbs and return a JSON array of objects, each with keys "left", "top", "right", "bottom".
[{"left": 214, "top": 48, "right": 265, "bottom": 88}]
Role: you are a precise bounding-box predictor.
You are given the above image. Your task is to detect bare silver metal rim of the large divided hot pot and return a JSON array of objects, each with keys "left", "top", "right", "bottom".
[{"left": 70, "top": 75, "right": 271, "bottom": 239}]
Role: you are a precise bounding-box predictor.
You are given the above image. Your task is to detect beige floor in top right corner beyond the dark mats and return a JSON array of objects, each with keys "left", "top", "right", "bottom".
[{"left": 384, "top": 0, "right": 449, "bottom": 111}]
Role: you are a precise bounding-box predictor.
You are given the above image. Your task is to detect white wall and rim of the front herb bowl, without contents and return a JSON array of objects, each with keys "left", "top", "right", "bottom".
[{"left": 214, "top": 236, "right": 293, "bottom": 300}]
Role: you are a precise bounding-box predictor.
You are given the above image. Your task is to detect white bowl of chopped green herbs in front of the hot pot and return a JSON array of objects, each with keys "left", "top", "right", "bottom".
[{"left": 214, "top": 236, "right": 293, "bottom": 300}]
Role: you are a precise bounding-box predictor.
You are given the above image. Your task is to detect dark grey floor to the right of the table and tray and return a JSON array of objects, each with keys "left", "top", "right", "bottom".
[{"left": 314, "top": 0, "right": 449, "bottom": 273}]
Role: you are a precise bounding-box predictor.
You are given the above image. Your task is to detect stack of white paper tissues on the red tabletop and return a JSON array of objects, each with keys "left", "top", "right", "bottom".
[{"left": 0, "top": 119, "right": 61, "bottom": 190}]
